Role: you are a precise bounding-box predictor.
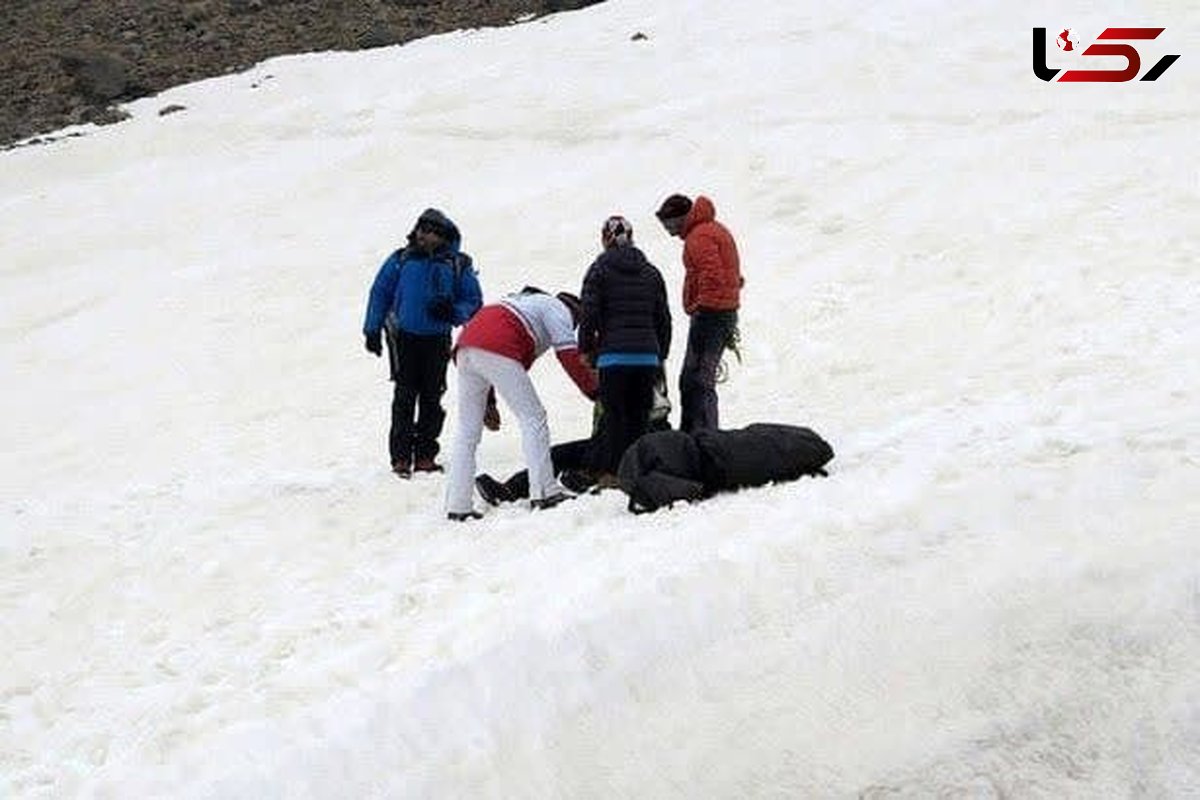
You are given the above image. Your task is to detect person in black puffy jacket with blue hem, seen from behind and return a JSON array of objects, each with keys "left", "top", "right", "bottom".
[{"left": 578, "top": 216, "right": 671, "bottom": 486}]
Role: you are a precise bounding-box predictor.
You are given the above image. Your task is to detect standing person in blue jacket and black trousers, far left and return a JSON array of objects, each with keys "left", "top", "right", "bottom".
[{"left": 362, "top": 209, "right": 484, "bottom": 477}]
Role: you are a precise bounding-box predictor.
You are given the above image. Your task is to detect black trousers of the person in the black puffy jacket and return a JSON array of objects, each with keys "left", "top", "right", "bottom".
[{"left": 590, "top": 366, "right": 659, "bottom": 475}]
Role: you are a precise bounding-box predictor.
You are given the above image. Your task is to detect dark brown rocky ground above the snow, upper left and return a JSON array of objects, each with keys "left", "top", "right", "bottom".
[{"left": 0, "top": 0, "right": 600, "bottom": 149}]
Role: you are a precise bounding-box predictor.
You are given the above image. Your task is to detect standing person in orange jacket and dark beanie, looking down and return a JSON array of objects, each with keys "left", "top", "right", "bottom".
[{"left": 655, "top": 194, "right": 745, "bottom": 433}]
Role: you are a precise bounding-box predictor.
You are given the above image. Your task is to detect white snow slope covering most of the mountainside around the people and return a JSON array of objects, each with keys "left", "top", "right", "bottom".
[{"left": 0, "top": 0, "right": 1200, "bottom": 800}]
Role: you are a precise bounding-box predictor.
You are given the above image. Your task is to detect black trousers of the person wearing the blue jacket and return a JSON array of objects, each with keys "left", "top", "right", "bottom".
[{"left": 388, "top": 331, "right": 450, "bottom": 464}]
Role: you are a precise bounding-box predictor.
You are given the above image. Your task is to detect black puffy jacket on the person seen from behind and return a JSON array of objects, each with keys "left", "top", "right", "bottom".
[{"left": 580, "top": 245, "right": 671, "bottom": 361}]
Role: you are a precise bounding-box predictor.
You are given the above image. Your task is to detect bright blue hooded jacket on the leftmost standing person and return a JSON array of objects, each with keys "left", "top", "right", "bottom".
[{"left": 362, "top": 211, "right": 484, "bottom": 336}]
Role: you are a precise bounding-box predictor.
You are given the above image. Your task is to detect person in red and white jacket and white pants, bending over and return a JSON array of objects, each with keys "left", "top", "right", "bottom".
[{"left": 446, "top": 287, "right": 598, "bottom": 522}]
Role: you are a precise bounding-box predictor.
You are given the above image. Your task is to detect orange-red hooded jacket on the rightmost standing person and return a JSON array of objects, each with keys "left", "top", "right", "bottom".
[{"left": 683, "top": 194, "right": 744, "bottom": 314}]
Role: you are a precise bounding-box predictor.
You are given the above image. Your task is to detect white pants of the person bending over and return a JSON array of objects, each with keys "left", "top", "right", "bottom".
[{"left": 446, "top": 348, "right": 563, "bottom": 513}]
